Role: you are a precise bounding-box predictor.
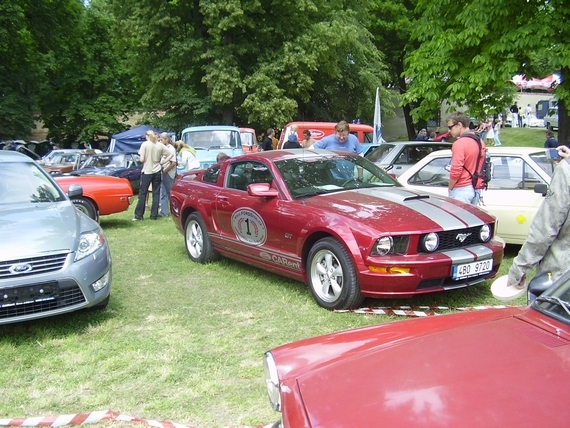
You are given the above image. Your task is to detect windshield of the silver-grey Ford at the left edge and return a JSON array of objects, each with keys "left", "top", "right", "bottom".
[{"left": 0, "top": 162, "right": 65, "bottom": 205}]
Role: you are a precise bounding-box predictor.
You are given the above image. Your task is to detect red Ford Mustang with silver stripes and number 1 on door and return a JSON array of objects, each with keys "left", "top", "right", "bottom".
[{"left": 170, "top": 149, "right": 504, "bottom": 309}]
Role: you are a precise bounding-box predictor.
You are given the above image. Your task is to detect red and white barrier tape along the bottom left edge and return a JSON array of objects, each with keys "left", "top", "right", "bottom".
[{"left": 0, "top": 410, "right": 272, "bottom": 428}]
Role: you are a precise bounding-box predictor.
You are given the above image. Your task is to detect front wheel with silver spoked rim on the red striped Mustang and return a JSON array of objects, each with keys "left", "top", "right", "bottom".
[{"left": 307, "top": 238, "right": 364, "bottom": 309}]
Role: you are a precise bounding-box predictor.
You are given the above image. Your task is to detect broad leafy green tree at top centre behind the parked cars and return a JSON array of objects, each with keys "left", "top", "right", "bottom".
[{"left": 105, "top": 0, "right": 384, "bottom": 128}]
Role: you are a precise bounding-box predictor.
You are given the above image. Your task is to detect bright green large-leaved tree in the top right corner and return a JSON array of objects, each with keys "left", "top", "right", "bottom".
[{"left": 404, "top": 0, "right": 570, "bottom": 143}]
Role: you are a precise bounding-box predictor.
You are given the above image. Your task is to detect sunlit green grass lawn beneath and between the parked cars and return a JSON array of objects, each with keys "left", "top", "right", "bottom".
[{"left": 0, "top": 128, "right": 544, "bottom": 428}]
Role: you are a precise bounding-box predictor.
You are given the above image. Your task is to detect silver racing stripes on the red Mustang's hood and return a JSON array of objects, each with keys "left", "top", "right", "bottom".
[{"left": 358, "top": 187, "right": 482, "bottom": 230}]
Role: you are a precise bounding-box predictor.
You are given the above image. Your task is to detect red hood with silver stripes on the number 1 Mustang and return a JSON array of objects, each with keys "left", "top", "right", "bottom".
[{"left": 305, "top": 187, "right": 494, "bottom": 233}]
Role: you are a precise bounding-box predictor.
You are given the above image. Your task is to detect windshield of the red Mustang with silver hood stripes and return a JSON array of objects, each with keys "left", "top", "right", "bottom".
[{"left": 275, "top": 156, "right": 399, "bottom": 199}]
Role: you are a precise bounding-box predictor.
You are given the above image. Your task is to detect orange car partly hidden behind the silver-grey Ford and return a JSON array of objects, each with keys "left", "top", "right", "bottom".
[{"left": 54, "top": 174, "right": 134, "bottom": 221}]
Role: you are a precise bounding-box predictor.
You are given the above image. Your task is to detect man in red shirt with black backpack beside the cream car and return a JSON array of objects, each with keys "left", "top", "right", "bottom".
[{"left": 447, "top": 111, "right": 486, "bottom": 205}]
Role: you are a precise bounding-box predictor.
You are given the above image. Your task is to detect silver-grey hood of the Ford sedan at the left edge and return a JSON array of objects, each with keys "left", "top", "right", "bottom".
[{"left": 0, "top": 201, "right": 81, "bottom": 260}]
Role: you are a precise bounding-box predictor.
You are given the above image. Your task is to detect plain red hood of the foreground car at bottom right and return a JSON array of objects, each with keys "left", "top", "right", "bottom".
[{"left": 276, "top": 308, "right": 570, "bottom": 427}]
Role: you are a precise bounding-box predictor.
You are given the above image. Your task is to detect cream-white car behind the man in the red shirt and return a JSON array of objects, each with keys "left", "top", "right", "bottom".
[{"left": 398, "top": 147, "right": 555, "bottom": 244}]
